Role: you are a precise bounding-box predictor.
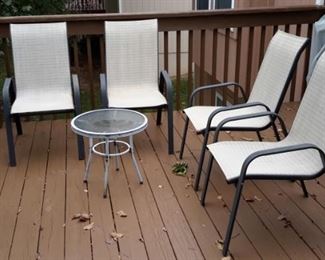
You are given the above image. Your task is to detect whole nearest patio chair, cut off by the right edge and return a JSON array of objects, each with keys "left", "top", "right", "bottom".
[{"left": 205, "top": 44, "right": 325, "bottom": 255}]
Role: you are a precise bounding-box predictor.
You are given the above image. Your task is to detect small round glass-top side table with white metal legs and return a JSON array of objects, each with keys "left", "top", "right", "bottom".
[{"left": 71, "top": 108, "right": 148, "bottom": 198}]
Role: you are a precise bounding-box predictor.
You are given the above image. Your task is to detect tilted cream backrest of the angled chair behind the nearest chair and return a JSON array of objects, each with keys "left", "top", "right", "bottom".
[{"left": 249, "top": 30, "right": 308, "bottom": 112}]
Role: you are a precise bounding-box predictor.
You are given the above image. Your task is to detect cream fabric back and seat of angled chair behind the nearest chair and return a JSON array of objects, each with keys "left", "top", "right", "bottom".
[{"left": 184, "top": 30, "right": 306, "bottom": 132}]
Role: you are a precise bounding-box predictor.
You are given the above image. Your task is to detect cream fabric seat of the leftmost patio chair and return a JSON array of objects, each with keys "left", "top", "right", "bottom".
[{"left": 11, "top": 91, "right": 74, "bottom": 114}]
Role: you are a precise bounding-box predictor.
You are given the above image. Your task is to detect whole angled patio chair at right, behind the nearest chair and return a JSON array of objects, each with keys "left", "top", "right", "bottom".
[{"left": 180, "top": 30, "right": 309, "bottom": 190}]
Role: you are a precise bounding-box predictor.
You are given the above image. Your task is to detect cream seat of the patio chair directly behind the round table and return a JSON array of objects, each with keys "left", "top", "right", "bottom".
[{"left": 108, "top": 86, "right": 167, "bottom": 108}]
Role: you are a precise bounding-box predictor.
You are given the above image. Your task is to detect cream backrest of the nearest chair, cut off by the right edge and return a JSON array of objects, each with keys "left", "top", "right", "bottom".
[{"left": 287, "top": 49, "right": 325, "bottom": 151}]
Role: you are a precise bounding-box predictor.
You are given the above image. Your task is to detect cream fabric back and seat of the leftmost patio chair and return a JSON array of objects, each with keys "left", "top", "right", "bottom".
[{"left": 10, "top": 23, "right": 74, "bottom": 114}]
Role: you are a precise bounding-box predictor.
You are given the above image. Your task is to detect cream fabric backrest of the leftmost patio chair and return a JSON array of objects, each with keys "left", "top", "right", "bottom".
[{"left": 10, "top": 23, "right": 72, "bottom": 97}]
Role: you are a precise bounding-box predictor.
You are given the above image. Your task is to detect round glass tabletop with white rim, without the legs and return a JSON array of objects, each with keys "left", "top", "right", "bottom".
[{"left": 71, "top": 108, "right": 148, "bottom": 138}]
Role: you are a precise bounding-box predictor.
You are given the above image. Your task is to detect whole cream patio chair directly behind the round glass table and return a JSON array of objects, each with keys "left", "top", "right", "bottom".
[{"left": 100, "top": 19, "right": 174, "bottom": 154}]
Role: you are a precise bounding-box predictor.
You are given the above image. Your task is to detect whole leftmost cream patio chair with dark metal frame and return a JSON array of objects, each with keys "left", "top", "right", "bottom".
[{"left": 3, "top": 23, "right": 84, "bottom": 166}]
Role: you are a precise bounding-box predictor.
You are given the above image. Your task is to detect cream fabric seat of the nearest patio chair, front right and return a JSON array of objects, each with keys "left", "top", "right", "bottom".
[{"left": 208, "top": 138, "right": 323, "bottom": 182}]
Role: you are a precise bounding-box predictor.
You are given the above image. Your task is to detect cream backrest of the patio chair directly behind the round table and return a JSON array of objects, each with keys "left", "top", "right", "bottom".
[{"left": 105, "top": 19, "right": 158, "bottom": 91}]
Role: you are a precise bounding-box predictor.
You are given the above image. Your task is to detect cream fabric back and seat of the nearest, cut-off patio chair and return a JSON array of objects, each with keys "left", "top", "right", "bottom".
[{"left": 208, "top": 45, "right": 325, "bottom": 182}]
